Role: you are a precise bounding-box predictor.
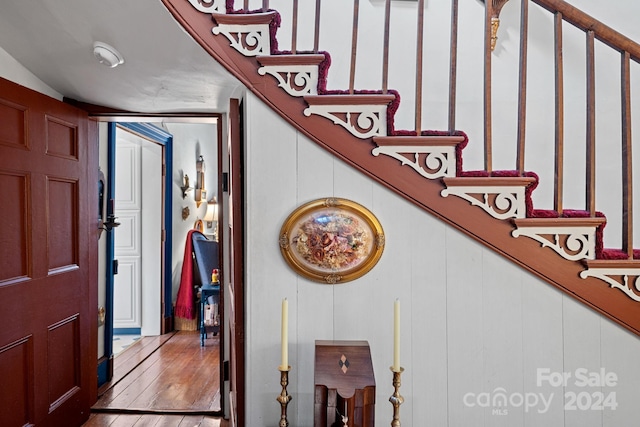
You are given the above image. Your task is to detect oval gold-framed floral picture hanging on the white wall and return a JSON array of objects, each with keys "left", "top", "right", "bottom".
[{"left": 280, "top": 197, "right": 385, "bottom": 284}]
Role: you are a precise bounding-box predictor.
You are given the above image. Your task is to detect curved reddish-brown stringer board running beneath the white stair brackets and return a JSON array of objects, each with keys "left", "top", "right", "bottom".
[{"left": 162, "top": 0, "right": 640, "bottom": 335}]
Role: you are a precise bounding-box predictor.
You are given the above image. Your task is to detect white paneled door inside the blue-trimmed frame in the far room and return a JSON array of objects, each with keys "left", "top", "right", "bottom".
[{"left": 113, "top": 128, "right": 162, "bottom": 336}]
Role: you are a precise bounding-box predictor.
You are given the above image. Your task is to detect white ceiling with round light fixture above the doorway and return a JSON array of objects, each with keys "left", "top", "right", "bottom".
[{"left": 0, "top": 0, "right": 241, "bottom": 113}]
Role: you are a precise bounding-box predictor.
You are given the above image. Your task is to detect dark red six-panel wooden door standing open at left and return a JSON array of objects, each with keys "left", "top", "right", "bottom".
[{"left": 0, "top": 79, "right": 98, "bottom": 427}]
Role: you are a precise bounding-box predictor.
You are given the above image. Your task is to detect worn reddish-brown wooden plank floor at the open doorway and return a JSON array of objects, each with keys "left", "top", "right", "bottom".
[{"left": 84, "top": 331, "right": 227, "bottom": 427}]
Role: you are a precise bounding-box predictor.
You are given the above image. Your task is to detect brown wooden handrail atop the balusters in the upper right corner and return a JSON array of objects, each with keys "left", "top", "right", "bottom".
[{"left": 532, "top": 0, "right": 640, "bottom": 62}]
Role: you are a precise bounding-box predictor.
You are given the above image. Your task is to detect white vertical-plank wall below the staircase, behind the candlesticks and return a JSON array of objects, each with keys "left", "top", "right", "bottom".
[{"left": 245, "top": 94, "right": 640, "bottom": 427}]
